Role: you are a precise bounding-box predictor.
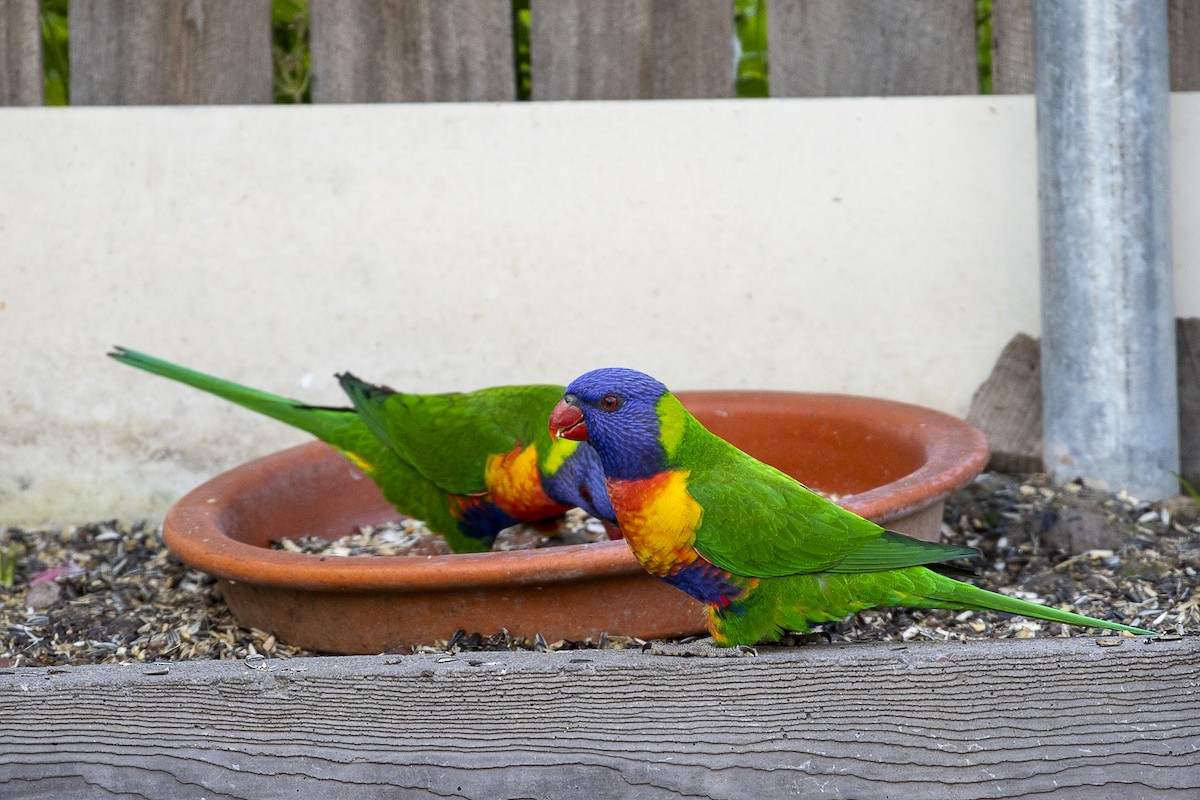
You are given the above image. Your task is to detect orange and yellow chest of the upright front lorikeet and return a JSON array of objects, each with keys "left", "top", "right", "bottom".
[{"left": 608, "top": 470, "right": 703, "bottom": 577}]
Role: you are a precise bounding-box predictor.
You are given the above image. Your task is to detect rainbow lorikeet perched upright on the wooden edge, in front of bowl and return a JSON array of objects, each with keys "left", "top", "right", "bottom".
[{"left": 550, "top": 368, "right": 1152, "bottom": 649}]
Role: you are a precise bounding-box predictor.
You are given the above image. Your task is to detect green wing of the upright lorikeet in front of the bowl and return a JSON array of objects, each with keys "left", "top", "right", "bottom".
[{"left": 674, "top": 410, "right": 976, "bottom": 577}]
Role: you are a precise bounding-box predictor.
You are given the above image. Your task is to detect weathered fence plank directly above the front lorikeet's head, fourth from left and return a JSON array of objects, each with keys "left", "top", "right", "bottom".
[{"left": 529, "top": 0, "right": 736, "bottom": 100}]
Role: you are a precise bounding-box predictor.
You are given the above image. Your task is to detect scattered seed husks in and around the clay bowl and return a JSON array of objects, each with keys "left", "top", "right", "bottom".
[{"left": 0, "top": 473, "right": 1200, "bottom": 667}]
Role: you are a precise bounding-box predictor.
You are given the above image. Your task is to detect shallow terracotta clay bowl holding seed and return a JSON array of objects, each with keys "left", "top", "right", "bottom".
[{"left": 163, "top": 391, "right": 988, "bottom": 652}]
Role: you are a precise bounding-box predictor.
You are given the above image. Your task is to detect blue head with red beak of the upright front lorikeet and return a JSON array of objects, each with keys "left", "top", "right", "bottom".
[{"left": 550, "top": 367, "right": 668, "bottom": 480}]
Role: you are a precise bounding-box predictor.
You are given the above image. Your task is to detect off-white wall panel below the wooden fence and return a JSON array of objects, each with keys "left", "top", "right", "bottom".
[{"left": 7, "top": 95, "right": 1200, "bottom": 525}]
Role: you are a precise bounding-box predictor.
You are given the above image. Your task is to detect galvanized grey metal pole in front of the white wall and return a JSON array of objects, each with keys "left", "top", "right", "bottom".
[{"left": 1033, "top": 0, "right": 1180, "bottom": 499}]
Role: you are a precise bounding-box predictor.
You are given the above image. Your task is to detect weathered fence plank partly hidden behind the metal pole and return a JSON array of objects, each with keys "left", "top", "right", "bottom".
[{"left": 991, "top": 0, "right": 1200, "bottom": 95}]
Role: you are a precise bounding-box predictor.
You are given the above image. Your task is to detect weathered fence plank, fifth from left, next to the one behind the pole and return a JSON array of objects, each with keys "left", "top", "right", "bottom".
[{"left": 767, "top": 0, "right": 979, "bottom": 97}]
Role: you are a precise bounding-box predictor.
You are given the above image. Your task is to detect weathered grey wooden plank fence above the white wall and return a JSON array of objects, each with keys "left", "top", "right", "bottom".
[{"left": 0, "top": 0, "right": 1200, "bottom": 106}]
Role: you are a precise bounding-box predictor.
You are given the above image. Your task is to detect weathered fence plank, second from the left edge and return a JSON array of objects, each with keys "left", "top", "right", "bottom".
[{"left": 68, "top": 0, "right": 272, "bottom": 106}]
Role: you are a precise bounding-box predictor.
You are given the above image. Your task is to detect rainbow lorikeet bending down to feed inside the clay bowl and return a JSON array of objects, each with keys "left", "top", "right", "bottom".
[{"left": 108, "top": 348, "right": 619, "bottom": 553}]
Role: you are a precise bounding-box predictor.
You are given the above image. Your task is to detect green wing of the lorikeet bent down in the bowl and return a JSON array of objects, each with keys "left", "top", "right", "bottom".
[{"left": 338, "top": 374, "right": 564, "bottom": 494}]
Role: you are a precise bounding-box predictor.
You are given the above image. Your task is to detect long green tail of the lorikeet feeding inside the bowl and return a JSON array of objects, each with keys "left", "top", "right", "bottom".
[{"left": 108, "top": 347, "right": 353, "bottom": 441}]
